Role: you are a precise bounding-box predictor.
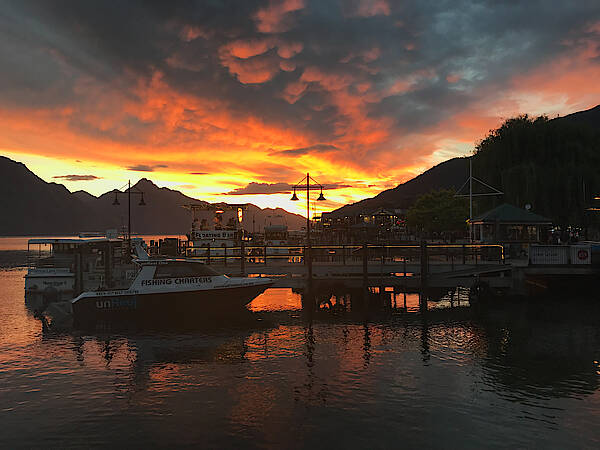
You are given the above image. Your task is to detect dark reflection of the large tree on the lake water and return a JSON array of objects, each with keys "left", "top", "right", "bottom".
[{"left": 477, "top": 302, "right": 600, "bottom": 400}]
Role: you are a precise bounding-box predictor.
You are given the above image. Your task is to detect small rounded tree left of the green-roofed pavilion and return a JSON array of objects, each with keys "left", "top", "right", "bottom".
[{"left": 406, "top": 190, "right": 469, "bottom": 233}]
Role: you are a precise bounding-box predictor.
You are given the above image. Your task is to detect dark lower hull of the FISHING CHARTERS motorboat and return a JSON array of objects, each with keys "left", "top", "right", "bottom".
[{"left": 73, "top": 283, "right": 272, "bottom": 321}]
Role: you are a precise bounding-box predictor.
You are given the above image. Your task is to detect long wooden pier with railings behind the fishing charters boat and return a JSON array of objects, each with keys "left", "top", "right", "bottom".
[{"left": 186, "top": 242, "right": 597, "bottom": 294}]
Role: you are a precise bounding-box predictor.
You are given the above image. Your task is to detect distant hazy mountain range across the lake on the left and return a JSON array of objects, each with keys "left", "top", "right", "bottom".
[{"left": 0, "top": 156, "right": 306, "bottom": 236}]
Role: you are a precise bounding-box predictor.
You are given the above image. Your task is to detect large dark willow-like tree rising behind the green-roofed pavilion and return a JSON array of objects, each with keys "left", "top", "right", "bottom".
[{"left": 473, "top": 111, "right": 600, "bottom": 226}]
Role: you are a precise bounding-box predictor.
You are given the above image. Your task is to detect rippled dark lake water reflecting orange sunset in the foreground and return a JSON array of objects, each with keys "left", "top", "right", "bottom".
[{"left": 0, "top": 246, "right": 600, "bottom": 448}]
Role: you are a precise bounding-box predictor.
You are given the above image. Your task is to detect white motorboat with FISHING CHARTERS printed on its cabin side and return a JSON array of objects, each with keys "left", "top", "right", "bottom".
[{"left": 71, "top": 258, "right": 273, "bottom": 320}]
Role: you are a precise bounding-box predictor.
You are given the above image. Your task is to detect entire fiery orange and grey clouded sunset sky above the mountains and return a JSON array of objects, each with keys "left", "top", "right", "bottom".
[{"left": 0, "top": 0, "right": 600, "bottom": 213}]
